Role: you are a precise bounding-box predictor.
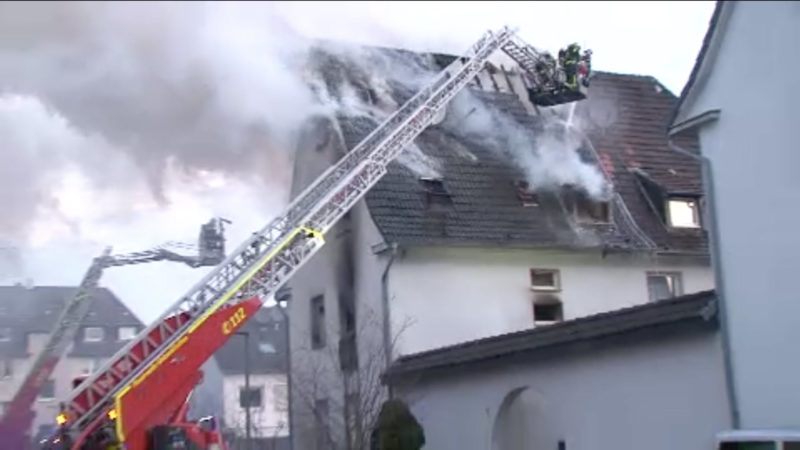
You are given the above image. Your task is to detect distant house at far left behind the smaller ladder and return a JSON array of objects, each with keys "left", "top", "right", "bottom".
[{"left": 0, "top": 285, "right": 143, "bottom": 442}]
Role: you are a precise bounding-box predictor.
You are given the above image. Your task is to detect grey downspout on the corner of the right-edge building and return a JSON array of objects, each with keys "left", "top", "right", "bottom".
[{"left": 667, "top": 137, "right": 740, "bottom": 429}]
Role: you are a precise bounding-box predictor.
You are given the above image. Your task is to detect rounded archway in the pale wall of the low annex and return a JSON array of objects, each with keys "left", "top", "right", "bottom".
[{"left": 492, "top": 386, "right": 561, "bottom": 450}]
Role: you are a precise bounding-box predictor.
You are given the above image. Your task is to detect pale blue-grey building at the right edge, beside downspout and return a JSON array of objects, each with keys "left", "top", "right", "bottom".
[{"left": 669, "top": 2, "right": 800, "bottom": 432}]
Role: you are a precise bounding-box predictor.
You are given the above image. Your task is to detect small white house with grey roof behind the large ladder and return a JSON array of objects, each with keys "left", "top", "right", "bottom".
[{"left": 214, "top": 307, "right": 289, "bottom": 448}]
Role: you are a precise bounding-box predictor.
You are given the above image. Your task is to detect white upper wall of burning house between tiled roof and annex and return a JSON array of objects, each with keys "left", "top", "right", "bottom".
[{"left": 389, "top": 248, "right": 713, "bottom": 356}]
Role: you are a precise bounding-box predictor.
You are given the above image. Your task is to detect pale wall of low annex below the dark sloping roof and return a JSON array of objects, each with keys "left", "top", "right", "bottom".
[{"left": 396, "top": 332, "right": 729, "bottom": 450}]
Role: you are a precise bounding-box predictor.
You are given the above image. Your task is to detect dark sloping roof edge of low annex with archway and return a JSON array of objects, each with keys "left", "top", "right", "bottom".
[{"left": 385, "top": 291, "right": 718, "bottom": 382}]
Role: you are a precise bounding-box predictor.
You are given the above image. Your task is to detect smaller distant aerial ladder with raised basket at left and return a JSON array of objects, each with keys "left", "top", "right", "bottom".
[{"left": 0, "top": 218, "right": 230, "bottom": 449}]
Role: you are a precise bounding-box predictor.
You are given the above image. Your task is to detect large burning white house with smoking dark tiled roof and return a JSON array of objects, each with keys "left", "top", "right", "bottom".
[{"left": 290, "top": 44, "right": 713, "bottom": 450}]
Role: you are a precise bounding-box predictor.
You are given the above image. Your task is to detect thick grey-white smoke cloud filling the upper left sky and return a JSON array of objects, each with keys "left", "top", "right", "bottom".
[{"left": 0, "top": 2, "right": 314, "bottom": 244}]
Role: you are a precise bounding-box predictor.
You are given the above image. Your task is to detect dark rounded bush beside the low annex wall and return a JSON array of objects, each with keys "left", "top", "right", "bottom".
[{"left": 373, "top": 399, "right": 425, "bottom": 450}]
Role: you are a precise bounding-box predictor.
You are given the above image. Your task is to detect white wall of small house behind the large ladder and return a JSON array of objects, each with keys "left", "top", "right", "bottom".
[{"left": 222, "top": 374, "right": 289, "bottom": 438}]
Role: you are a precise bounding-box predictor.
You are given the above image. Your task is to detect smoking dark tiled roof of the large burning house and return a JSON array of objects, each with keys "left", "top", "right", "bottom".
[{"left": 310, "top": 45, "right": 707, "bottom": 255}]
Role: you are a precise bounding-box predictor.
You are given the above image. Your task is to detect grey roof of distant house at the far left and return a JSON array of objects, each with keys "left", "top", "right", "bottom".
[{"left": 0, "top": 285, "right": 142, "bottom": 358}]
